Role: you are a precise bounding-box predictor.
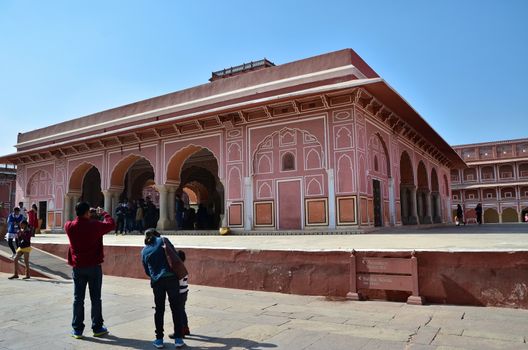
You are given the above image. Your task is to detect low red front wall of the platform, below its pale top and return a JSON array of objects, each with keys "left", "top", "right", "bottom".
[{"left": 35, "top": 244, "right": 528, "bottom": 309}]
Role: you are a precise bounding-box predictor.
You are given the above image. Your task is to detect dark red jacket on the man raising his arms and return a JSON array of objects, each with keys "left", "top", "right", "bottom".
[{"left": 64, "top": 212, "right": 115, "bottom": 267}]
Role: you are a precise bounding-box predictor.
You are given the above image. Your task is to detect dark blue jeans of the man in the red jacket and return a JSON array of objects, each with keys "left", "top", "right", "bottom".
[{"left": 72, "top": 265, "right": 104, "bottom": 333}]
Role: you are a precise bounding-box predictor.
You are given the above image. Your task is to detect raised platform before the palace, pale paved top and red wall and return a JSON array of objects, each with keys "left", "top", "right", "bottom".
[{"left": 26, "top": 226, "right": 528, "bottom": 308}]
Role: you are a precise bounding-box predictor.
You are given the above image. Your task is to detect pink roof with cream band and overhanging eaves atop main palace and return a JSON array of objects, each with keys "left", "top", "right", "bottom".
[{"left": 0, "top": 49, "right": 465, "bottom": 167}]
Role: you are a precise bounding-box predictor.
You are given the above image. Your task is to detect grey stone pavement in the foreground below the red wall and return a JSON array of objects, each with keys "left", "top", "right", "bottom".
[{"left": 0, "top": 273, "right": 528, "bottom": 350}]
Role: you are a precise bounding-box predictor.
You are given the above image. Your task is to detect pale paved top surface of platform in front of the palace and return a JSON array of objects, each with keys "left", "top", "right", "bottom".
[{"left": 33, "top": 224, "right": 528, "bottom": 252}]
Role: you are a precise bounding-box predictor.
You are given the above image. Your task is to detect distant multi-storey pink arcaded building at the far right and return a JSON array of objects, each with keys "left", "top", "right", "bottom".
[{"left": 451, "top": 139, "right": 528, "bottom": 223}]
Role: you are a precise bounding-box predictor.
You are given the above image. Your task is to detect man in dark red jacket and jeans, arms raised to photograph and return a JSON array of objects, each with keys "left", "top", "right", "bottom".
[{"left": 64, "top": 202, "right": 115, "bottom": 339}]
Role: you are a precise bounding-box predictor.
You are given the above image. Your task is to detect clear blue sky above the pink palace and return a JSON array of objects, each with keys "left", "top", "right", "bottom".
[{"left": 0, "top": 0, "right": 528, "bottom": 155}]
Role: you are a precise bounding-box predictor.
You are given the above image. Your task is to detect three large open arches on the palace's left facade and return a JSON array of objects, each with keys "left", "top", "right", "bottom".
[{"left": 64, "top": 145, "right": 224, "bottom": 230}]
